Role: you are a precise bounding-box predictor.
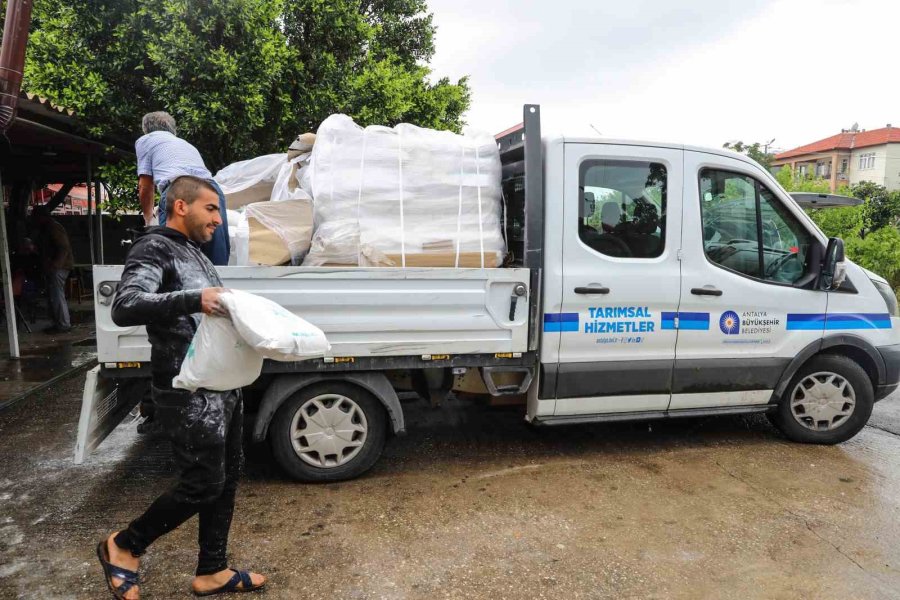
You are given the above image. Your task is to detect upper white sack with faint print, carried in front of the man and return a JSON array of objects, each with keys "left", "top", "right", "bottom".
[{"left": 220, "top": 290, "right": 331, "bottom": 362}]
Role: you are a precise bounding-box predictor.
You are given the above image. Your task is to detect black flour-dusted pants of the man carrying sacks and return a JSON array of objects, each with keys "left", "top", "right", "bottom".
[{"left": 116, "top": 386, "right": 244, "bottom": 575}]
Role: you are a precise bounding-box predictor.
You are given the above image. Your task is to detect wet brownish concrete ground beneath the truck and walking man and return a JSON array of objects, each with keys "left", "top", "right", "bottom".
[{"left": 0, "top": 377, "right": 900, "bottom": 599}]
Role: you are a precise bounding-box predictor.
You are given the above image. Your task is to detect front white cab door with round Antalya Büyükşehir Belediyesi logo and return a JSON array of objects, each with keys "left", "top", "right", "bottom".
[{"left": 670, "top": 151, "right": 827, "bottom": 410}]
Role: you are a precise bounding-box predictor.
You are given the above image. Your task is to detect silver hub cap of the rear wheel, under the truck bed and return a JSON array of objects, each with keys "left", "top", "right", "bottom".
[{"left": 291, "top": 394, "right": 369, "bottom": 468}]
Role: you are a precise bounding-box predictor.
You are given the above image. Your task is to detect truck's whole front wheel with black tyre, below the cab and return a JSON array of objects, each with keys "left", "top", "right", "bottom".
[{"left": 771, "top": 354, "right": 875, "bottom": 444}]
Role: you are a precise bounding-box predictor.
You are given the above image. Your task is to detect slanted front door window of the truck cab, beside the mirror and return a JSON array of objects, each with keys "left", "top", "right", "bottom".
[{"left": 700, "top": 169, "right": 813, "bottom": 283}]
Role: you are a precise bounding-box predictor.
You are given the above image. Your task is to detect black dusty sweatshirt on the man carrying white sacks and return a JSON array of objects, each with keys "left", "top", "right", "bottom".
[{"left": 112, "top": 227, "right": 222, "bottom": 389}]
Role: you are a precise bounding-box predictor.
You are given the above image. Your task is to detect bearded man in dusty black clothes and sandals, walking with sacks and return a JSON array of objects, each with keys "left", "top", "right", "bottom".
[{"left": 97, "top": 176, "right": 265, "bottom": 599}]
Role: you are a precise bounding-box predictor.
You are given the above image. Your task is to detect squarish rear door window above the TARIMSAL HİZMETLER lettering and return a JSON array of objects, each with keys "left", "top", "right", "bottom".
[{"left": 578, "top": 160, "right": 666, "bottom": 258}]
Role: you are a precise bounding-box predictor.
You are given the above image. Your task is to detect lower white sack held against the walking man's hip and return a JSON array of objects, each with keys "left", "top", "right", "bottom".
[{"left": 172, "top": 314, "right": 263, "bottom": 392}]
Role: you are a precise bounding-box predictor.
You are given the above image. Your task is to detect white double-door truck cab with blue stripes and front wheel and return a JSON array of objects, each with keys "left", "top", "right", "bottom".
[{"left": 530, "top": 124, "right": 900, "bottom": 443}]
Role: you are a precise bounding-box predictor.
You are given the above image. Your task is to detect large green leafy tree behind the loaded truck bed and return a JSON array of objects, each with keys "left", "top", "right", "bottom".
[{"left": 15, "top": 0, "right": 470, "bottom": 213}]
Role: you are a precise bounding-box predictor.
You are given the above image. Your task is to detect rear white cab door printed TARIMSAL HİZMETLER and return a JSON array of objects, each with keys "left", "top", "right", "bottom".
[{"left": 545, "top": 143, "right": 683, "bottom": 416}]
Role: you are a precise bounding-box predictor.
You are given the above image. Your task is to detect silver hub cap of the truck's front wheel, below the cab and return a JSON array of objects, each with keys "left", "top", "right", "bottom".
[{"left": 791, "top": 372, "right": 856, "bottom": 431}]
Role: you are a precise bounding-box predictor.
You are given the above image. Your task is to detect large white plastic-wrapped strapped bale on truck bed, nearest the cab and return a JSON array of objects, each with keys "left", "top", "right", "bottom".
[{"left": 300, "top": 115, "right": 506, "bottom": 266}]
